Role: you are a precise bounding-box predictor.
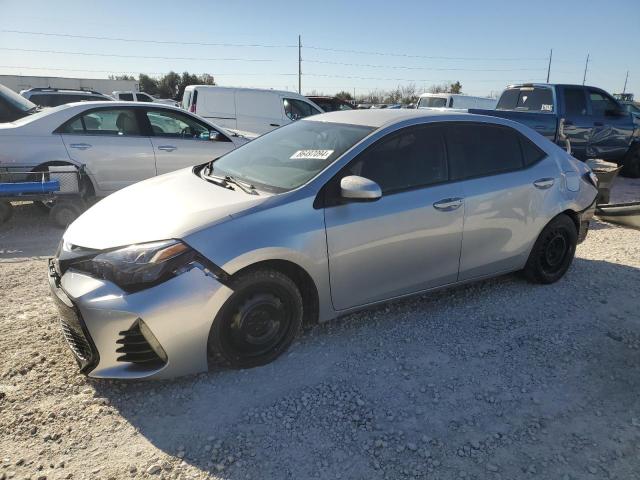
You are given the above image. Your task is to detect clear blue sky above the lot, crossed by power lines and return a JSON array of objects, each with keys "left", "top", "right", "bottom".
[{"left": 0, "top": 0, "right": 640, "bottom": 97}]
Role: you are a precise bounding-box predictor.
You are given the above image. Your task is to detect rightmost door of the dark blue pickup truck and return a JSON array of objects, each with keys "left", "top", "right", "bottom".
[{"left": 587, "top": 88, "right": 633, "bottom": 160}]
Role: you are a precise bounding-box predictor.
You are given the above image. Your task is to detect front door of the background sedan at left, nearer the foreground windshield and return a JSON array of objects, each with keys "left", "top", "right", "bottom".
[{"left": 144, "top": 107, "right": 234, "bottom": 175}]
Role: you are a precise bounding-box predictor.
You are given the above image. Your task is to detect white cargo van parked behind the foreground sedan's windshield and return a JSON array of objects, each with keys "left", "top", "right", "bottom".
[{"left": 182, "top": 85, "right": 322, "bottom": 135}]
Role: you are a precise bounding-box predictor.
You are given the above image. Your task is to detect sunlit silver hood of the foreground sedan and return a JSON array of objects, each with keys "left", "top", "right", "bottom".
[{"left": 63, "top": 168, "right": 270, "bottom": 250}]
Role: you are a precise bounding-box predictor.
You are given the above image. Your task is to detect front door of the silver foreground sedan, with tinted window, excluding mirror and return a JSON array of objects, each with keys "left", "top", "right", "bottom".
[{"left": 325, "top": 126, "right": 464, "bottom": 310}]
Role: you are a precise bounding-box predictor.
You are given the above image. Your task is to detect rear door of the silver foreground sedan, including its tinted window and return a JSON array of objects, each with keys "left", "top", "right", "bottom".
[{"left": 446, "top": 122, "right": 560, "bottom": 281}]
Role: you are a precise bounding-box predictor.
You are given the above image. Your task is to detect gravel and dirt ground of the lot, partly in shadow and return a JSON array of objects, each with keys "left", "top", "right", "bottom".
[{"left": 0, "top": 177, "right": 640, "bottom": 480}]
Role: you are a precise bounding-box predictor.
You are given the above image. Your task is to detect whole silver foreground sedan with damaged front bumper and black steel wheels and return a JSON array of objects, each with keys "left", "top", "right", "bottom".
[{"left": 49, "top": 110, "right": 597, "bottom": 378}]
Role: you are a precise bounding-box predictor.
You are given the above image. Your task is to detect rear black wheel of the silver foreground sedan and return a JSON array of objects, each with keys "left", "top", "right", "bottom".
[{"left": 523, "top": 213, "right": 578, "bottom": 283}]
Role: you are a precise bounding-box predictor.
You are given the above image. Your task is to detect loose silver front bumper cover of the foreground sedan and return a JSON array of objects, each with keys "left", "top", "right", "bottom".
[{"left": 49, "top": 262, "right": 232, "bottom": 379}]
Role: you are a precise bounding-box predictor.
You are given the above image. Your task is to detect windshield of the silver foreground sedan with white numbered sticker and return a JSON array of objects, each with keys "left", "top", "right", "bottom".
[{"left": 212, "top": 120, "right": 374, "bottom": 192}]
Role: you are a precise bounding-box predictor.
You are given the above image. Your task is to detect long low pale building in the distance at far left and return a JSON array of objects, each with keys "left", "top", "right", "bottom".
[{"left": 0, "top": 75, "right": 139, "bottom": 95}]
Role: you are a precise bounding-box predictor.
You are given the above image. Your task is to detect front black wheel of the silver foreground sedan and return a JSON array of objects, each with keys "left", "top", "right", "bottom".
[{"left": 208, "top": 269, "right": 303, "bottom": 368}]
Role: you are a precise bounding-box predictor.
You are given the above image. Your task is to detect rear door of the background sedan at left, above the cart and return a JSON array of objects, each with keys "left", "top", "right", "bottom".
[{"left": 57, "top": 107, "right": 156, "bottom": 195}]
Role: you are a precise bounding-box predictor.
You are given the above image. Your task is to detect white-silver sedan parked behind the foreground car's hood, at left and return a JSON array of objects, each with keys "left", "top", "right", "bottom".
[{"left": 0, "top": 101, "right": 248, "bottom": 197}]
